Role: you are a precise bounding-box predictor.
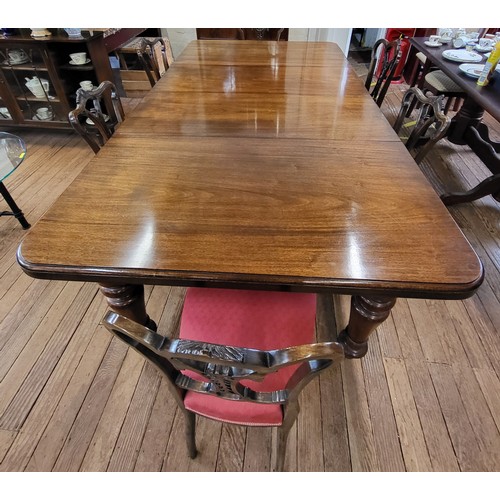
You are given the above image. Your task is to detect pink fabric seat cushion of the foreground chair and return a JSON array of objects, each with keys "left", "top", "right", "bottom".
[{"left": 179, "top": 288, "right": 316, "bottom": 426}]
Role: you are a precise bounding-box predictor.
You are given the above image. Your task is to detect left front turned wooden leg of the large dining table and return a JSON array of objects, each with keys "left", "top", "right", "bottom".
[{"left": 99, "top": 283, "right": 157, "bottom": 331}]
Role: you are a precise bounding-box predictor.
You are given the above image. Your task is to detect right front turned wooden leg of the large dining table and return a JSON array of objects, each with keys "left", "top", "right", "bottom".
[{"left": 337, "top": 295, "right": 396, "bottom": 358}]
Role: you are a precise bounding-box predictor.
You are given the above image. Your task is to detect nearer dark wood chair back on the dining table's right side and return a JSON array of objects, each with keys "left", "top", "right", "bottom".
[{"left": 393, "top": 87, "right": 451, "bottom": 163}]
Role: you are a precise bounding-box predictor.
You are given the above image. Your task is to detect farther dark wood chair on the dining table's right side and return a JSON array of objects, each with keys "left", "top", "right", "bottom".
[{"left": 365, "top": 38, "right": 401, "bottom": 107}]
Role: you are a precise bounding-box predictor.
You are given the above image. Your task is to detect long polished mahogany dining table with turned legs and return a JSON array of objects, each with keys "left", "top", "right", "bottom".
[{"left": 17, "top": 40, "right": 483, "bottom": 358}]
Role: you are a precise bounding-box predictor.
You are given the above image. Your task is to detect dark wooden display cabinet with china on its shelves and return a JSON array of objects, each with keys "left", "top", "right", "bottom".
[{"left": 0, "top": 28, "right": 144, "bottom": 128}]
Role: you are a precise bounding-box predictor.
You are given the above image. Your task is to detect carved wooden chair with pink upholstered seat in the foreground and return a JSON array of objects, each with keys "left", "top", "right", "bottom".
[{"left": 103, "top": 288, "right": 344, "bottom": 471}]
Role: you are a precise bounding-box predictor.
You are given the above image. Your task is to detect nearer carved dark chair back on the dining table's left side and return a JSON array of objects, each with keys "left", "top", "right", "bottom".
[{"left": 68, "top": 81, "right": 125, "bottom": 153}]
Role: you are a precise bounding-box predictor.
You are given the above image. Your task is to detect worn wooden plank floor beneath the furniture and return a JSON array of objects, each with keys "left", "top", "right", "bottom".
[{"left": 0, "top": 83, "right": 500, "bottom": 472}]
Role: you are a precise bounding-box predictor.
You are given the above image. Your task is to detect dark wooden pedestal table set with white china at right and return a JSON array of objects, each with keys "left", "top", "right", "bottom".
[{"left": 410, "top": 37, "right": 500, "bottom": 205}]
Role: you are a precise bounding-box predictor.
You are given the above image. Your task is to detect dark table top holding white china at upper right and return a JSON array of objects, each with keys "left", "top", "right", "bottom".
[{"left": 410, "top": 37, "right": 500, "bottom": 121}]
